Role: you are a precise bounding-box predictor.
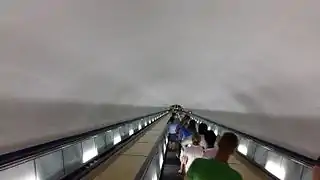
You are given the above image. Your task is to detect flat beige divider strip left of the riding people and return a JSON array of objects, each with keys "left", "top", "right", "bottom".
[{"left": 86, "top": 116, "right": 168, "bottom": 180}]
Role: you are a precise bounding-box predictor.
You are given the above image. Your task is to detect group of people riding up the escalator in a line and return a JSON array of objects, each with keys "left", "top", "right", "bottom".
[{"left": 168, "top": 113, "right": 242, "bottom": 180}]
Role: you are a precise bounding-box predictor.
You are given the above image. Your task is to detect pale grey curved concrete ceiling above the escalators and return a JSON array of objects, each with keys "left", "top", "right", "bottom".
[{"left": 0, "top": 0, "right": 320, "bottom": 116}]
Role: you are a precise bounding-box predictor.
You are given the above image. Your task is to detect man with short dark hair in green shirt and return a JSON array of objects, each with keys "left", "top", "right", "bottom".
[{"left": 187, "top": 132, "right": 242, "bottom": 180}]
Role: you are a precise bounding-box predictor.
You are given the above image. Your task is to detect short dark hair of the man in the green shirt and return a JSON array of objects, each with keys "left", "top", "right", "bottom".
[{"left": 218, "top": 132, "right": 239, "bottom": 154}]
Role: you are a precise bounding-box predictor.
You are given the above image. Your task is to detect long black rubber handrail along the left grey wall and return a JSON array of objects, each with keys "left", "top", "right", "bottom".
[{"left": 0, "top": 110, "right": 167, "bottom": 170}]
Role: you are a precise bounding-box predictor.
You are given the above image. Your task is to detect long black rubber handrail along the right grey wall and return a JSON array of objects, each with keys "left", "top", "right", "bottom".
[{"left": 191, "top": 113, "right": 317, "bottom": 167}]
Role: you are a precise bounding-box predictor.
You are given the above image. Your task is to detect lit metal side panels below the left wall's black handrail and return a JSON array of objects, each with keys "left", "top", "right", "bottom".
[{"left": 0, "top": 110, "right": 168, "bottom": 180}]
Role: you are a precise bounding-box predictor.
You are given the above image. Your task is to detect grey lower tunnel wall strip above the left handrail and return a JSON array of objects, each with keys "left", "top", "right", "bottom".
[{"left": 0, "top": 99, "right": 164, "bottom": 154}]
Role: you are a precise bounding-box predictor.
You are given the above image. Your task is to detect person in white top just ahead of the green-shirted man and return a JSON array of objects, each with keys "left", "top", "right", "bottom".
[{"left": 179, "top": 133, "right": 204, "bottom": 174}]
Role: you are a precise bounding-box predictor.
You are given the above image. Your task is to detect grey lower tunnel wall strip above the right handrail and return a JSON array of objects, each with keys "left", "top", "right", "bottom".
[{"left": 194, "top": 110, "right": 320, "bottom": 159}]
